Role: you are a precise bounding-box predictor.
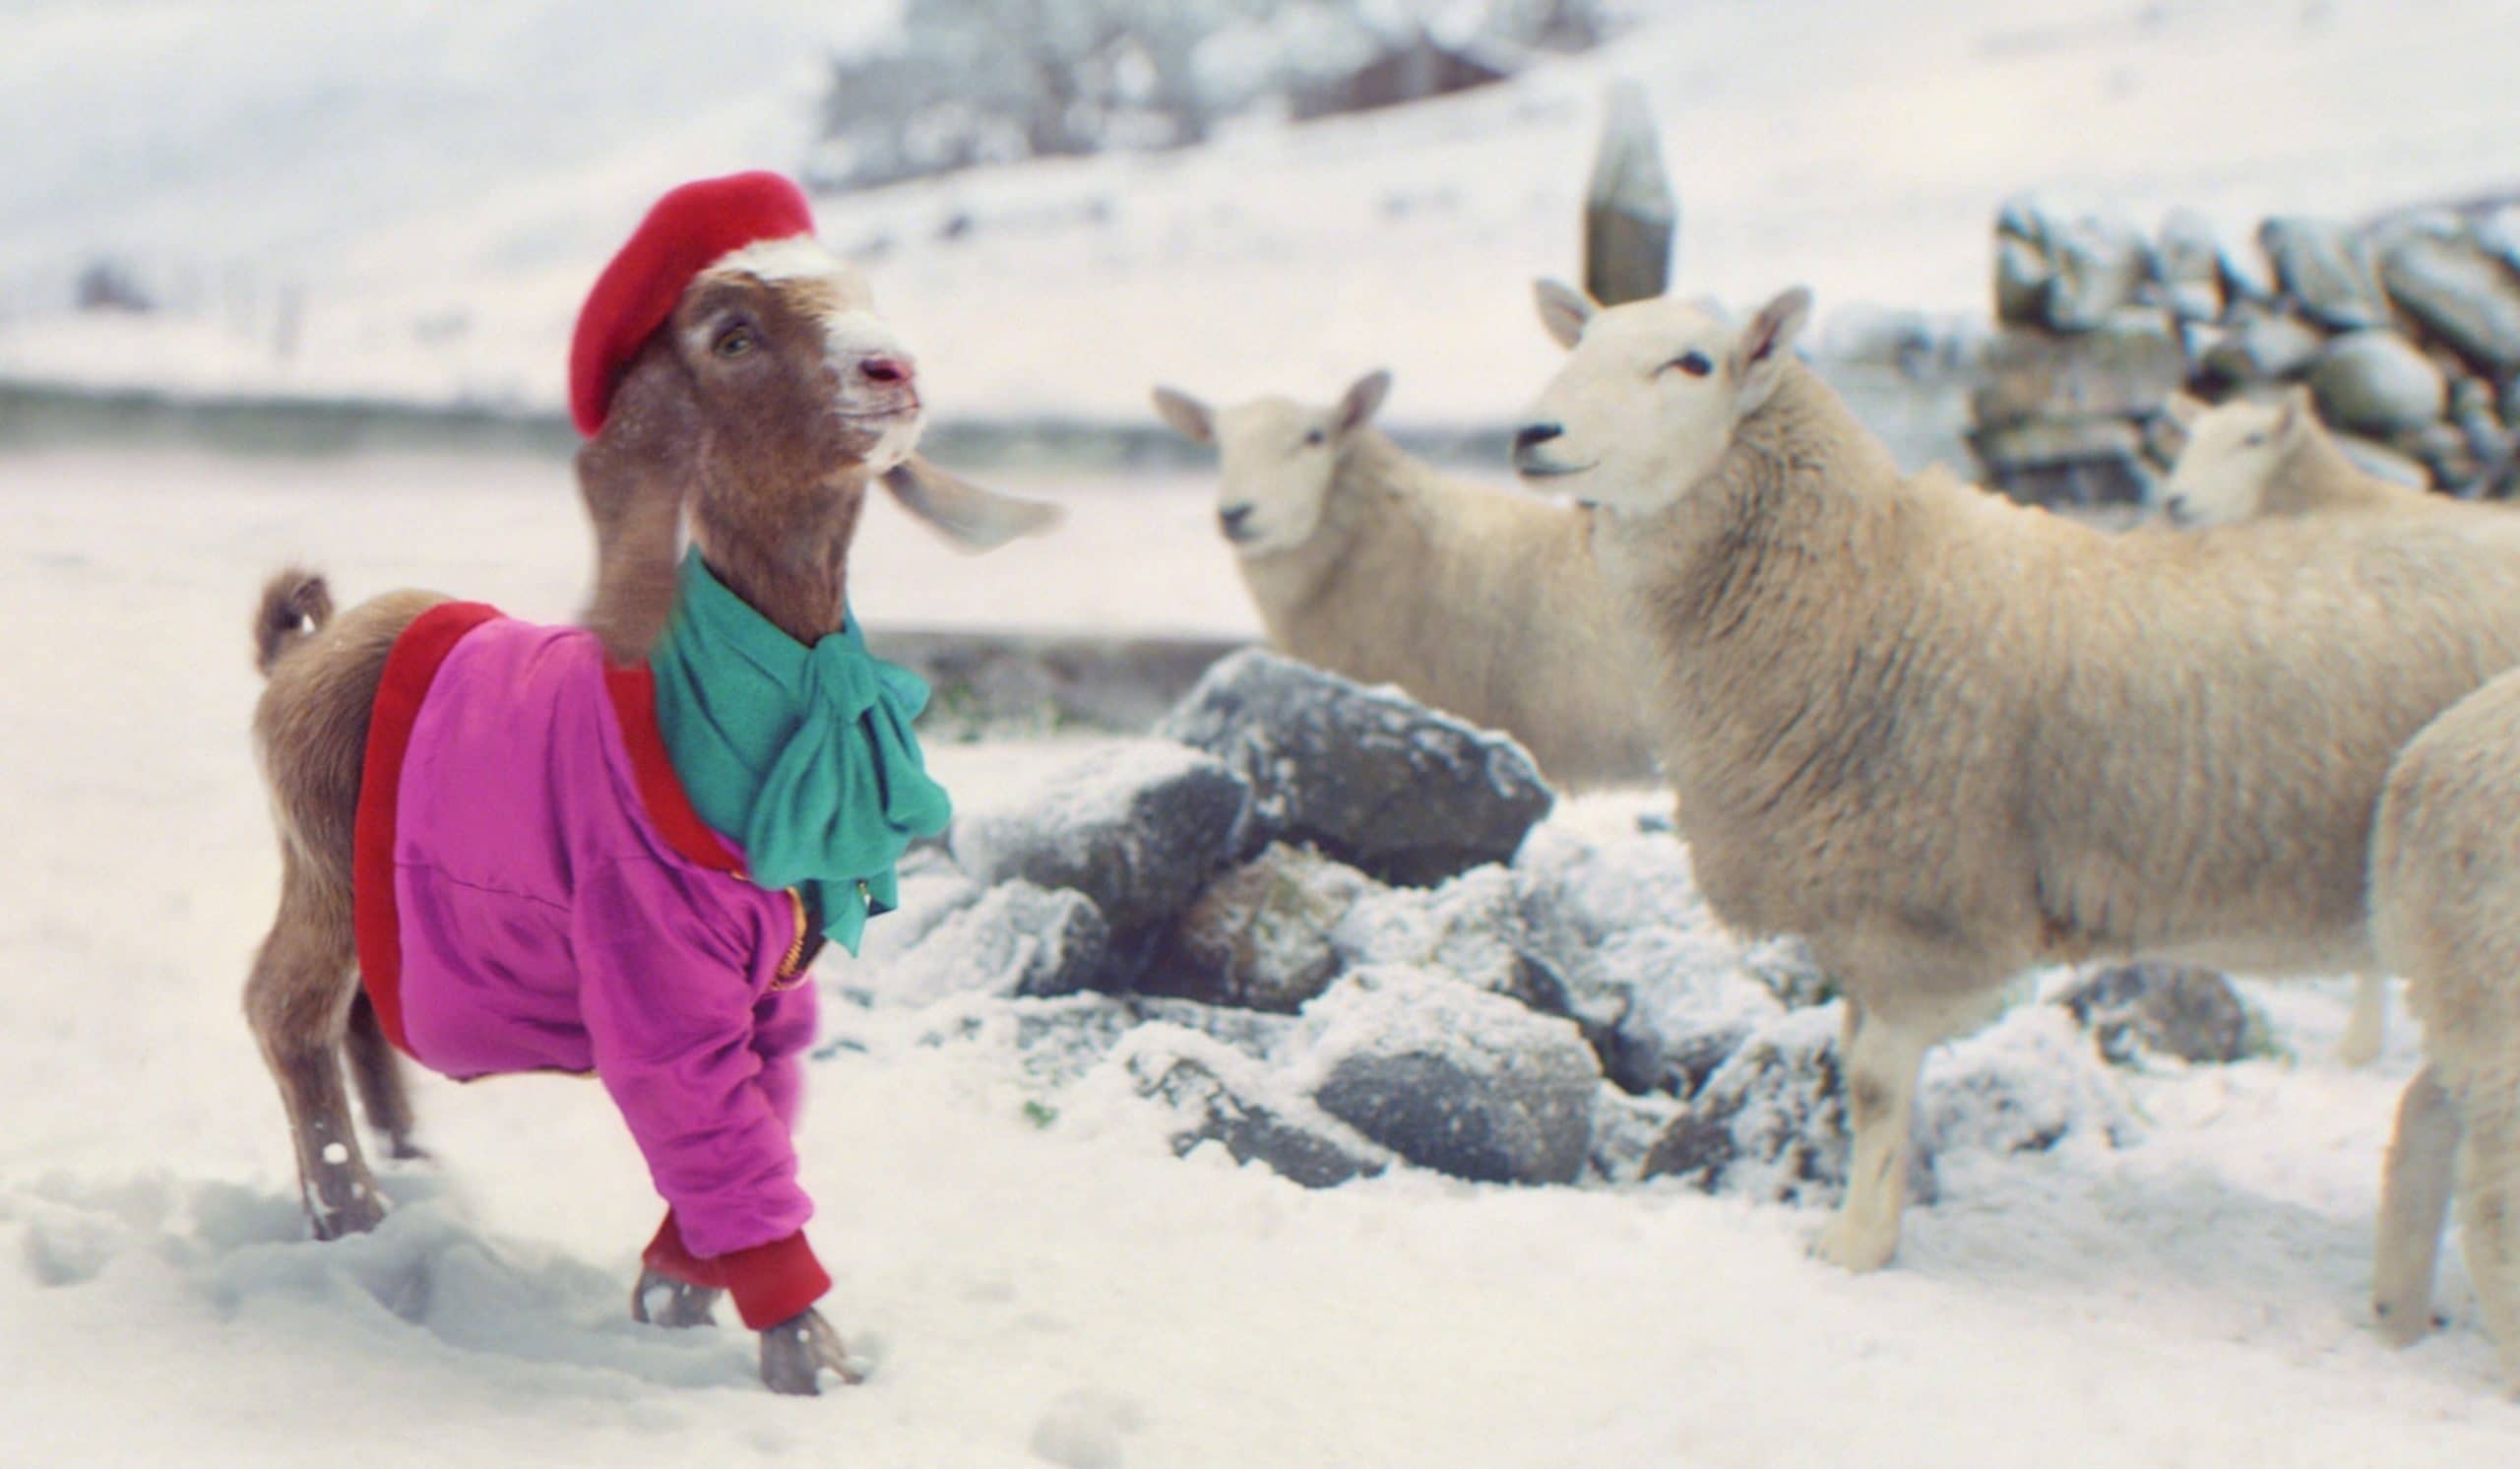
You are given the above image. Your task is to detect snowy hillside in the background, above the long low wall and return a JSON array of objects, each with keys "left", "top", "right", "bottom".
[{"left": 0, "top": 0, "right": 2520, "bottom": 423}]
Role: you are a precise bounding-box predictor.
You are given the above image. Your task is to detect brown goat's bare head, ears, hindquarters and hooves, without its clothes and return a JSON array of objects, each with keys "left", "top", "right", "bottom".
[{"left": 244, "top": 239, "right": 1056, "bottom": 1393}]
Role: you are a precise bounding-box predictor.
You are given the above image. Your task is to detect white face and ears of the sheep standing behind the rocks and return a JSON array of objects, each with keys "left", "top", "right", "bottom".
[{"left": 1154, "top": 373, "right": 1391, "bottom": 557}]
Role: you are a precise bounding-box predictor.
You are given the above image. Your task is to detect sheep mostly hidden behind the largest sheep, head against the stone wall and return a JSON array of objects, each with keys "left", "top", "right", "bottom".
[{"left": 2157, "top": 386, "right": 2483, "bottom": 1066}]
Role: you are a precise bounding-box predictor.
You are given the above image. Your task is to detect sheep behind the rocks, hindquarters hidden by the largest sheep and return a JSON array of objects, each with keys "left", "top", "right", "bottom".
[{"left": 1154, "top": 373, "right": 1656, "bottom": 786}]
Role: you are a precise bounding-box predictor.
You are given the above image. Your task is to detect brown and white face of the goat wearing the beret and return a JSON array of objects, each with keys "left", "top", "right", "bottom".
[{"left": 670, "top": 237, "right": 925, "bottom": 481}]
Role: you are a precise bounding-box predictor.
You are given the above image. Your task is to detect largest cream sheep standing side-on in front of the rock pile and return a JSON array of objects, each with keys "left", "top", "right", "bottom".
[{"left": 1515, "top": 285, "right": 2520, "bottom": 1270}]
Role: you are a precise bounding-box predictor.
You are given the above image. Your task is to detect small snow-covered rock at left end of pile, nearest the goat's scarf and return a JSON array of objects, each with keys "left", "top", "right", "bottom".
[{"left": 882, "top": 882, "right": 1111, "bottom": 1003}]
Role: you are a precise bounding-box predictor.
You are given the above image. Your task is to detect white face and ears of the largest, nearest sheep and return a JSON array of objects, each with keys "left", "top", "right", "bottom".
[{"left": 1515, "top": 283, "right": 1812, "bottom": 514}]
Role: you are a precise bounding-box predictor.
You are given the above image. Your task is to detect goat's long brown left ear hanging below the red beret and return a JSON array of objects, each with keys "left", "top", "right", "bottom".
[{"left": 577, "top": 333, "right": 701, "bottom": 666}]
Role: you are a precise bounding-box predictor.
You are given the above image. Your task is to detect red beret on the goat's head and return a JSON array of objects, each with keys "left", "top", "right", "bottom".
[{"left": 570, "top": 171, "right": 814, "bottom": 438}]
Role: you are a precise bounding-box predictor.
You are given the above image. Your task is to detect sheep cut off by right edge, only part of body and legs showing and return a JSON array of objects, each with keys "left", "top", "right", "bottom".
[{"left": 2371, "top": 672, "right": 2520, "bottom": 1393}]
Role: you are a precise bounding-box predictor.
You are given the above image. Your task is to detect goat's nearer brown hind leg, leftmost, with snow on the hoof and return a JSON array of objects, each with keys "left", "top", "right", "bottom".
[{"left": 244, "top": 852, "right": 386, "bottom": 1240}]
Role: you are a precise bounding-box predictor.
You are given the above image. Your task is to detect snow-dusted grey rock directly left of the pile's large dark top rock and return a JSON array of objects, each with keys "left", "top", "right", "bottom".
[{"left": 953, "top": 740, "right": 1250, "bottom": 940}]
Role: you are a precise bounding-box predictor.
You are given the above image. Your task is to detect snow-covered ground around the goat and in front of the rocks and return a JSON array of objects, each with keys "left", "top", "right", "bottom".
[{"left": 0, "top": 456, "right": 2520, "bottom": 1469}]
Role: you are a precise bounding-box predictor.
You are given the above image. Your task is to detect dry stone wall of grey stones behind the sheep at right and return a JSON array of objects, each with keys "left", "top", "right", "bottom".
[{"left": 1968, "top": 202, "right": 2520, "bottom": 506}]
